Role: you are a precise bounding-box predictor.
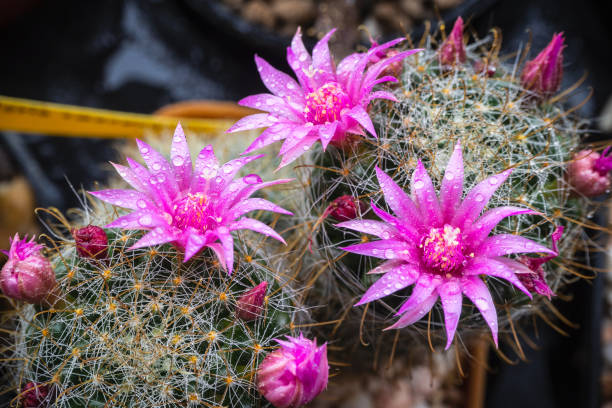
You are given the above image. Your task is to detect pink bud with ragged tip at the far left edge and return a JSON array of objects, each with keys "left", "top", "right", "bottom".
[{"left": 0, "top": 234, "right": 56, "bottom": 303}]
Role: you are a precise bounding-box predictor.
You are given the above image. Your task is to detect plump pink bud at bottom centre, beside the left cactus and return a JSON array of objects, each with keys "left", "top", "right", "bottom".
[{"left": 257, "top": 334, "right": 329, "bottom": 408}]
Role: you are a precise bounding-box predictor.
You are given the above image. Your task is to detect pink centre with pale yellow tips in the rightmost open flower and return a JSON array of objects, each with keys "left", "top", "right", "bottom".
[{"left": 419, "top": 224, "right": 466, "bottom": 275}]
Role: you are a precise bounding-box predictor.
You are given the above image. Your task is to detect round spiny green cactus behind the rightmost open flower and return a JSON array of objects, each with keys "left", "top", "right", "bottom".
[{"left": 296, "top": 29, "right": 591, "bottom": 354}]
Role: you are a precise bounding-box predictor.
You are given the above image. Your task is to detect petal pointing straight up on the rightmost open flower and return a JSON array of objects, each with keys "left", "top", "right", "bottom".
[{"left": 440, "top": 142, "right": 463, "bottom": 223}]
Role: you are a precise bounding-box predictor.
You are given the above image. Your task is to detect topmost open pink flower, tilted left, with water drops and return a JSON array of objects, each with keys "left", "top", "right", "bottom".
[{"left": 228, "top": 29, "right": 419, "bottom": 168}]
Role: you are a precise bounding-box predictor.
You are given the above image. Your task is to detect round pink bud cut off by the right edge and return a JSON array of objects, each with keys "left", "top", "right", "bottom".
[{"left": 567, "top": 147, "right": 612, "bottom": 197}]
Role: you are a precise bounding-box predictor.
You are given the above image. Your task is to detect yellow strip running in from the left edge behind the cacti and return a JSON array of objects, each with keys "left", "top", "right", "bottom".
[{"left": 0, "top": 95, "right": 234, "bottom": 138}]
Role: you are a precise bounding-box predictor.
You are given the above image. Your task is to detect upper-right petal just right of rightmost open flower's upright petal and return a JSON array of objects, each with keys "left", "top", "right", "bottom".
[{"left": 452, "top": 169, "right": 512, "bottom": 228}]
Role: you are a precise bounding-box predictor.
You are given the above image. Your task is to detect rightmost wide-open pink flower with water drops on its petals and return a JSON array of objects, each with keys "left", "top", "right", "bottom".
[{"left": 338, "top": 143, "right": 556, "bottom": 348}]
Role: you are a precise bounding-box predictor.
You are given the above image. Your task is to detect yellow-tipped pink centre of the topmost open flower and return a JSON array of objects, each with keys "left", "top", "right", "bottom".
[{"left": 304, "top": 82, "right": 350, "bottom": 125}]
